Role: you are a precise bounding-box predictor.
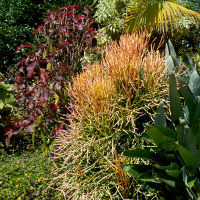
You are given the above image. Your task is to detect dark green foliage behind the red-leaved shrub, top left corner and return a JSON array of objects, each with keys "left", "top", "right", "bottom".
[{"left": 0, "top": 0, "right": 97, "bottom": 73}]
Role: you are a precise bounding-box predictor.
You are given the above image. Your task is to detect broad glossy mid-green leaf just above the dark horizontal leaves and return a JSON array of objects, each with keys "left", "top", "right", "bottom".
[{"left": 146, "top": 125, "right": 176, "bottom": 151}]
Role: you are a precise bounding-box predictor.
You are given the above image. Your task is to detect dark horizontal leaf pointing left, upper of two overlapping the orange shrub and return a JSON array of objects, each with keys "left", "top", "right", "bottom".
[{"left": 124, "top": 149, "right": 155, "bottom": 160}]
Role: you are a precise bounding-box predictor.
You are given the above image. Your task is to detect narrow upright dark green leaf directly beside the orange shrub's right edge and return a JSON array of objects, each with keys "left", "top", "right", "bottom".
[{"left": 169, "top": 74, "right": 183, "bottom": 122}]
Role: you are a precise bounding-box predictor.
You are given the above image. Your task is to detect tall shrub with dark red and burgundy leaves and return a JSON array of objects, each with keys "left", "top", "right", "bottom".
[{"left": 5, "top": 5, "right": 96, "bottom": 146}]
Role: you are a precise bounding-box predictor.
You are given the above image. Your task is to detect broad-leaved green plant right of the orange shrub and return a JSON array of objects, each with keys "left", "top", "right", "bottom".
[{"left": 124, "top": 66, "right": 200, "bottom": 199}]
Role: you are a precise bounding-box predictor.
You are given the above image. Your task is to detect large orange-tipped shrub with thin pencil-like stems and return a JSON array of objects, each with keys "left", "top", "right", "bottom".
[{"left": 52, "top": 33, "right": 166, "bottom": 199}]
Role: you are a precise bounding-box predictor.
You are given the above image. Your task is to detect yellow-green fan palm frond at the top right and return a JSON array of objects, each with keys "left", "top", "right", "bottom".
[{"left": 126, "top": 0, "right": 200, "bottom": 33}]
